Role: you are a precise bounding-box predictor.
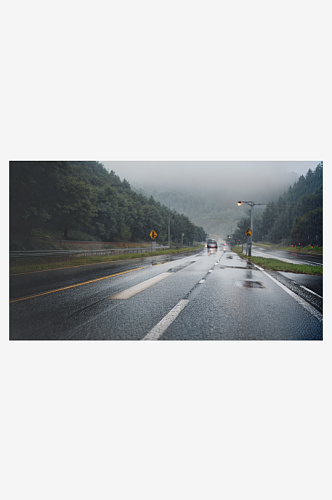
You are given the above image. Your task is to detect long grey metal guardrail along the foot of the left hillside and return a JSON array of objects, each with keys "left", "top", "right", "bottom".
[{"left": 9, "top": 245, "right": 169, "bottom": 259}]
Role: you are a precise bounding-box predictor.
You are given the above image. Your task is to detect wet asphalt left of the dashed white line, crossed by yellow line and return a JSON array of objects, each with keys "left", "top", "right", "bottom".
[{"left": 10, "top": 256, "right": 205, "bottom": 340}]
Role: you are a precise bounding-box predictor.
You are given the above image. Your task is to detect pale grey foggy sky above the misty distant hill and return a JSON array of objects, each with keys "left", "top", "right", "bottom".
[{"left": 101, "top": 160, "right": 320, "bottom": 199}]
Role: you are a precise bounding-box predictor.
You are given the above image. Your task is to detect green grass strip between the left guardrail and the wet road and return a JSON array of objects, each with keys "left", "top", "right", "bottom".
[{"left": 9, "top": 246, "right": 203, "bottom": 276}]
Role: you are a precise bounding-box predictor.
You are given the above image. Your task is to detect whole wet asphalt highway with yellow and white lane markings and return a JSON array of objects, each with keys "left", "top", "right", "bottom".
[{"left": 10, "top": 249, "right": 323, "bottom": 340}]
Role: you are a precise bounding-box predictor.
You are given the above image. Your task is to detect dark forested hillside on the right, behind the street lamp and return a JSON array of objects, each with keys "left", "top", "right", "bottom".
[{"left": 233, "top": 163, "right": 323, "bottom": 246}]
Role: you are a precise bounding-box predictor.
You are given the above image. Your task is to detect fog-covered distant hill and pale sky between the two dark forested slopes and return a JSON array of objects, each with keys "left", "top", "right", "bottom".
[{"left": 102, "top": 161, "right": 319, "bottom": 237}]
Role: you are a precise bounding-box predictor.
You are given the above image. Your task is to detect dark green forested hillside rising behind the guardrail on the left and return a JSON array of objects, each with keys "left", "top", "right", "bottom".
[{"left": 10, "top": 161, "right": 206, "bottom": 249}]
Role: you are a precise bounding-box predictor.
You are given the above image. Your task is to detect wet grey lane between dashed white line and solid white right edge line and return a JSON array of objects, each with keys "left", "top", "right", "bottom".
[{"left": 162, "top": 262, "right": 322, "bottom": 340}]
